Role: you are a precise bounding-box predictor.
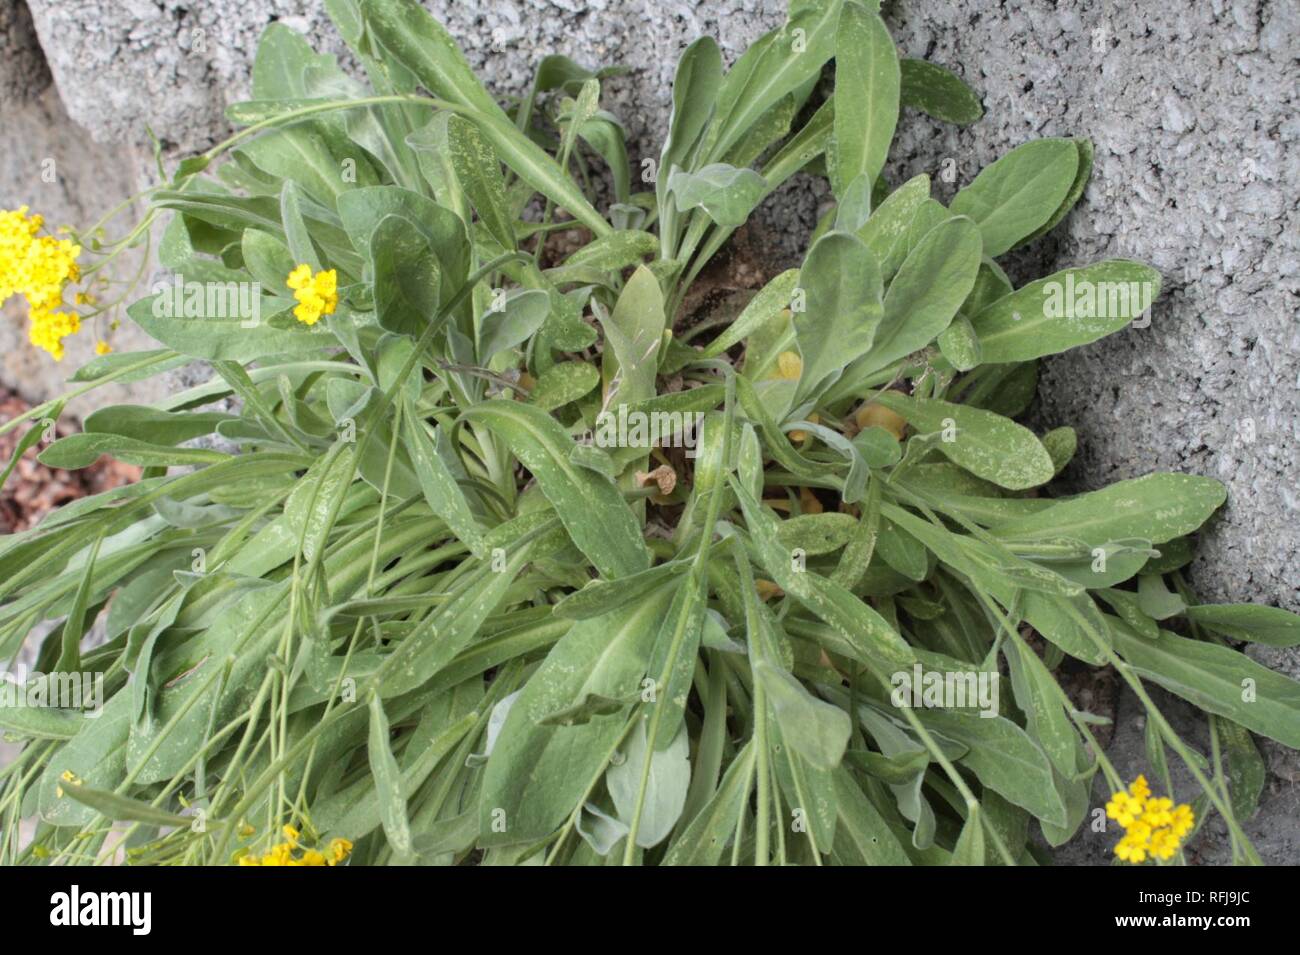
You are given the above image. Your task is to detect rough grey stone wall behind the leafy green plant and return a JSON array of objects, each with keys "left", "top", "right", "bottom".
[{"left": 0, "top": 0, "right": 1300, "bottom": 863}]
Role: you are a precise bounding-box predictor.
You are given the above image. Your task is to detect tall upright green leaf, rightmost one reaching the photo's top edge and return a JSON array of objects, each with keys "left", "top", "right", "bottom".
[{"left": 827, "top": 3, "right": 900, "bottom": 200}]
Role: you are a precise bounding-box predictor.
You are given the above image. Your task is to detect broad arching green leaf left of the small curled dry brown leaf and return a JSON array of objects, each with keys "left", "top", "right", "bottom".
[{"left": 465, "top": 400, "right": 650, "bottom": 577}]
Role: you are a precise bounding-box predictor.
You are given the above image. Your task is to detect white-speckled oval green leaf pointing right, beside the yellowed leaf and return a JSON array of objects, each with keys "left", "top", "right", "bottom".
[{"left": 876, "top": 391, "right": 1056, "bottom": 491}]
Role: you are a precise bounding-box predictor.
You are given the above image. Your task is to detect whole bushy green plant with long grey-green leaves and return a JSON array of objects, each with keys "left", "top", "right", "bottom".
[{"left": 0, "top": 0, "right": 1300, "bottom": 864}]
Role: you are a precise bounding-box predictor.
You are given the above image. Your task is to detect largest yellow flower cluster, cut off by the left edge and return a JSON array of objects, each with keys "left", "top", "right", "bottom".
[{"left": 0, "top": 205, "right": 81, "bottom": 361}]
